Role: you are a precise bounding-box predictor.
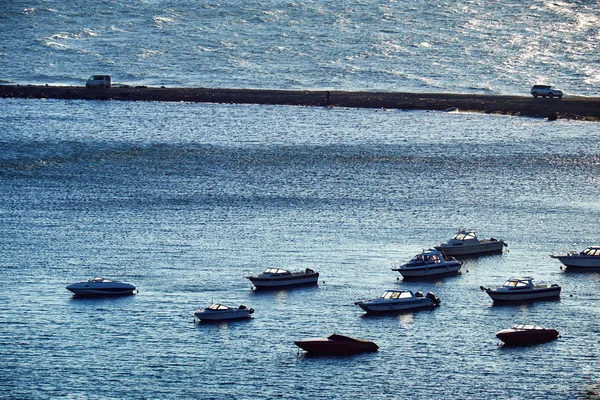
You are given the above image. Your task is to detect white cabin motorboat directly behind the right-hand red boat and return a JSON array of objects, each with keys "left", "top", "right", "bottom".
[{"left": 480, "top": 276, "right": 561, "bottom": 302}]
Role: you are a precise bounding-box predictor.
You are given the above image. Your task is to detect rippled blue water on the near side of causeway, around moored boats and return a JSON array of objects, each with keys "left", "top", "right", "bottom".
[{"left": 0, "top": 100, "right": 600, "bottom": 399}]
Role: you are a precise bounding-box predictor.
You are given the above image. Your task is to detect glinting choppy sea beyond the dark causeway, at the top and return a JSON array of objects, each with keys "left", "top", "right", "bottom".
[{"left": 0, "top": 0, "right": 600, "bottom": 96}]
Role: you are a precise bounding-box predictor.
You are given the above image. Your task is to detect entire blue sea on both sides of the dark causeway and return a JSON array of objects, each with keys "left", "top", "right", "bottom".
[{"left": 0, "top": 0, "right": 600, "bottom": 400}]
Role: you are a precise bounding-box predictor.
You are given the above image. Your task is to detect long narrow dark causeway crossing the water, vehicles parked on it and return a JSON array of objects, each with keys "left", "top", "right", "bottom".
[{"left": 0, "top": 85, "right": 600, "bottom": 121}]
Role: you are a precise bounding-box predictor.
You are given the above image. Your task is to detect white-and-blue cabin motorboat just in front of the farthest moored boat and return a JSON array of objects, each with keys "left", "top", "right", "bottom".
[{"left": 392, "top": 249, "right": 462, "bottom": 278}]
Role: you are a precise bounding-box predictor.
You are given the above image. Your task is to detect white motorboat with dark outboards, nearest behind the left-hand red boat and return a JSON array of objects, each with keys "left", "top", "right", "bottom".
[{"left": 354, "top": 290, "right": 440, "bottom": 313}]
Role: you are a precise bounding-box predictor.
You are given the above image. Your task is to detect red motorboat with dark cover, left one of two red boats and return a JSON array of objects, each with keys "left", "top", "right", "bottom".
[{"left": 294, "top": 333, "right": 379, "bottom": 355}]
